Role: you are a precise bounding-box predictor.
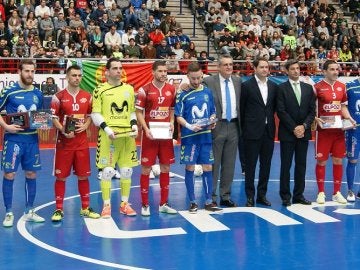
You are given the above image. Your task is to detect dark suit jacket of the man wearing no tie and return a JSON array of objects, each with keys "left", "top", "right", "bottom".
[{"left": 240, "top": 76, "right": 277, "bottom": 140}]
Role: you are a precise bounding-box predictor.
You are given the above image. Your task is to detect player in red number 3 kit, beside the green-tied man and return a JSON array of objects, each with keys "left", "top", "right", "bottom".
[{"left": 314, "top": 60, "right": 355, "bottom": 204}]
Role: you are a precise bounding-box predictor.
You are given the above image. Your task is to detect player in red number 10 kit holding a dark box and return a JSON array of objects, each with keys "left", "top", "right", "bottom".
[{"left": 51, "top": 66, "right": 100, "bottom": 221}]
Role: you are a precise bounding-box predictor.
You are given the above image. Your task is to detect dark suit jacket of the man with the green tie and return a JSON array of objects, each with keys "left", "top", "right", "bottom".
[{"left": 277, "top": 81, "right": 316, "bottom": 142}]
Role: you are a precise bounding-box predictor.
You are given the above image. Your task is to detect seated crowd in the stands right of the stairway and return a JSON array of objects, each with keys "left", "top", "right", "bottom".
[{"left": 193, "top": 0, "right": 360, "bottom": 74}]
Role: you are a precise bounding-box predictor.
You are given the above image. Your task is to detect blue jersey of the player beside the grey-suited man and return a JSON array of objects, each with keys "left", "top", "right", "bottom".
[{"left": 175, "top": 86, "right": 215, "bottom": 144}]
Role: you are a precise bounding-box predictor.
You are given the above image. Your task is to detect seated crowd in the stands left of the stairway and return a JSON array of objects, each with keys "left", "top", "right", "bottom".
[{"left": 0, "top": 0, "right": 214, "bottom": 73}]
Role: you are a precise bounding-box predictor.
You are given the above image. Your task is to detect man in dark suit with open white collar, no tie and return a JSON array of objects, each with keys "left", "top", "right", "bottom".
[{"left": 240, "top": 57, "right": 277, "bottom": 207}]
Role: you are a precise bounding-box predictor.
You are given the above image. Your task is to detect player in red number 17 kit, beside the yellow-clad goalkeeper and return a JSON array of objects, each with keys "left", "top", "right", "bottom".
[{"left": 135, "top": 61, "right": 177, "bottom": 216}]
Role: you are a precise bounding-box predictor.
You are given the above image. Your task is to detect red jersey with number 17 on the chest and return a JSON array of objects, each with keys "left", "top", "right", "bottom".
[{"left": 135, "top": 82, "right": 176, "bottom": 123}]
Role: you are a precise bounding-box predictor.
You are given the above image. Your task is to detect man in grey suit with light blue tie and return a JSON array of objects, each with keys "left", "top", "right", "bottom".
[{"left": 204, "top": 55, "right": 241, "bottom": 207}]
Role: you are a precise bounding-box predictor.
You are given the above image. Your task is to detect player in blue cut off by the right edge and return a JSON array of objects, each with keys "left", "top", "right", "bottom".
[{"left": 346, "top": 78, "right": 360, "bottom": 202}]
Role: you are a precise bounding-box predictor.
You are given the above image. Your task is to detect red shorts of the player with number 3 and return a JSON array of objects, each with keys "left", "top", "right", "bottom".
[{"left": 315, "top": 129, "right": 346, "bottom": 161}]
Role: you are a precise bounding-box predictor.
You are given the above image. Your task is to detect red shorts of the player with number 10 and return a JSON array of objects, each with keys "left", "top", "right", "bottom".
[{"left": 54, "top": 148, "right": 91, "bottom": 178}]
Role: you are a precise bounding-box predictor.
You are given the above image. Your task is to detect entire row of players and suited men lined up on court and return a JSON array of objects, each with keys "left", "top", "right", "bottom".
[{"left": 0, "top": 58, "right": 360, "bottom": 227}]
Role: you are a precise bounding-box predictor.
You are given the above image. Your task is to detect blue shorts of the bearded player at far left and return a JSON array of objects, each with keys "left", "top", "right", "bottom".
[{"left": 1, "top": 141, "right": 41, "bottom": 173}]
